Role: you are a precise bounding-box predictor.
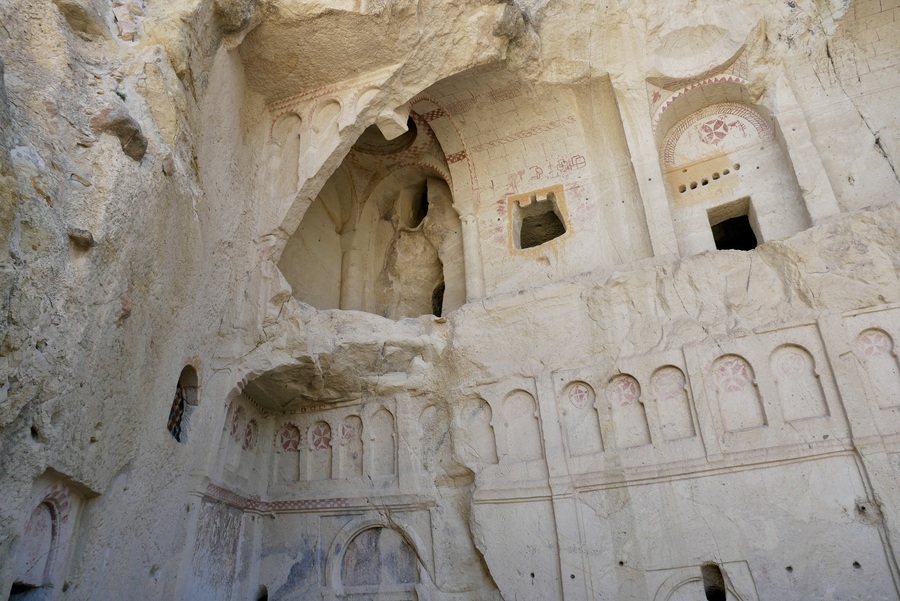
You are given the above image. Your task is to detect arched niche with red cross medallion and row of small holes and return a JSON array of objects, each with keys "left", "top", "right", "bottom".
[{"left": 648, "top": 68, "right": 812, "bottom": 255}]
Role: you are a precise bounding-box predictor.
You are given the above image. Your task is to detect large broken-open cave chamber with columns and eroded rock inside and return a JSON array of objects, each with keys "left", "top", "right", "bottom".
[{"left": 278, "top": 113, "right": 466, "bottom": 319}]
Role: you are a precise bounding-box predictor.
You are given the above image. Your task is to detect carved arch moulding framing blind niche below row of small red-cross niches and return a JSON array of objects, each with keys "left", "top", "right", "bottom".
[{"left": 325, "top": 512, "right": 434, "bottom": 597}]
